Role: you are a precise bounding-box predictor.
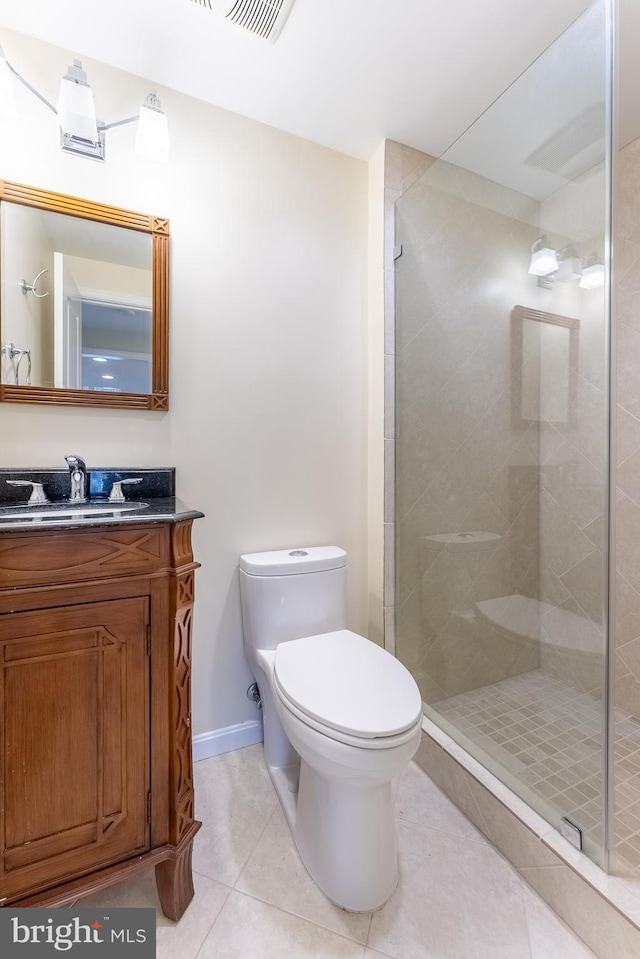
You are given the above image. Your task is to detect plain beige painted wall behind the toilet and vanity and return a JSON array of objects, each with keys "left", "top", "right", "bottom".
[{"left": 0, "top": 31, "right": 367, "bottom": 733}]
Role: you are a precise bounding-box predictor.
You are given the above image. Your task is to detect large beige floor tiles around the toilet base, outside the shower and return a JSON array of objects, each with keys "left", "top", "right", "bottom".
[{"left": 82, "top": 746, "right": 594, "bottom": 959}]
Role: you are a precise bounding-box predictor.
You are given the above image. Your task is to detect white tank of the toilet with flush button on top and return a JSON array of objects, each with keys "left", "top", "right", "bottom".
[{"left": 240, "top": 546, "right": 347, "bottom": 649}]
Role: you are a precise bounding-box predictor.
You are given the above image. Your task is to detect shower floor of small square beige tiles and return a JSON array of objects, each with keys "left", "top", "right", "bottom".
[{"left": 429, "top": 669, "right": 640, "bottom": 875}]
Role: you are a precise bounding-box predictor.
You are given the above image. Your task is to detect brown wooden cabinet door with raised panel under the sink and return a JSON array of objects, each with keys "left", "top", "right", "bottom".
[{"left": 0, "top": 597, "right": 149, "bottom": 899}]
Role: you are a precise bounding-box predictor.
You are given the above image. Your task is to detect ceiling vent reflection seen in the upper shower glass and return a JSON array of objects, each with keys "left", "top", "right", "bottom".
[{"left": 525, "top": 103, "right": 605, "bottom": 180}]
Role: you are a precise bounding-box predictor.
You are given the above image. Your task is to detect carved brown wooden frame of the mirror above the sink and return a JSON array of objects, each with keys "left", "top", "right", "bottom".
[{"left": 0, "top": 180, "right": 169, "bottom": 411}]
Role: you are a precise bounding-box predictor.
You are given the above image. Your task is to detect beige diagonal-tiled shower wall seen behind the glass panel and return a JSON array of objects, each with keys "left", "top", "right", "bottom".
[{"left": 387, "top": 137, "right": 606, "bottom": 704}]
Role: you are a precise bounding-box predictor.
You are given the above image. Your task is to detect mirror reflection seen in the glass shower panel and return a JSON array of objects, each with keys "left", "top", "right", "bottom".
[{"left": 512, "top": 306, "right": 580, "bottom": 429}]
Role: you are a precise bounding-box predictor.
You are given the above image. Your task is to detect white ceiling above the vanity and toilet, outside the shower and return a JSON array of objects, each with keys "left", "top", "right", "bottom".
[{"left": 0, "top": 0, "right": 589, "bottom": 159}]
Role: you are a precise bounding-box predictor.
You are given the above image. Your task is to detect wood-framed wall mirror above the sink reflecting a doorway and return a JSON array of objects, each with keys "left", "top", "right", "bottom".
[{"left": 0, "top": 181, "right": 169, "bottom": 410}]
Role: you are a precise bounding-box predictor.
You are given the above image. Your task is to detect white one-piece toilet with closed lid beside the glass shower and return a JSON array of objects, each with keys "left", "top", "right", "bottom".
[{"left": 240, "top": 546, "right": 422, "bottom": 912}]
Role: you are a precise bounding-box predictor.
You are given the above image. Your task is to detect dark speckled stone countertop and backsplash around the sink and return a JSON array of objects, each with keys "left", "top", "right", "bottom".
[{"left": 0, "top": 467, "right": 204, "bottom": 533}]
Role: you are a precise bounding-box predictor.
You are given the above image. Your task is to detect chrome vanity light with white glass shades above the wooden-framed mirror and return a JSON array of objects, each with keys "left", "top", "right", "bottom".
[{"left": 0, "top": 47, "right": 169, "bottom": 162}]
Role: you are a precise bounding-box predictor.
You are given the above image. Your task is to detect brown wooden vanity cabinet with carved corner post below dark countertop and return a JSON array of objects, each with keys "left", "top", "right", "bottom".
[{"left": 0, "top": 519, "right": 200, "bottom": 919}]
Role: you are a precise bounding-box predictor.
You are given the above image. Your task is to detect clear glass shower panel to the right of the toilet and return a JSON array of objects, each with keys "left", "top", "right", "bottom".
[{"left": 395, "top": 0, "right": 609, "bottom": 865}]
